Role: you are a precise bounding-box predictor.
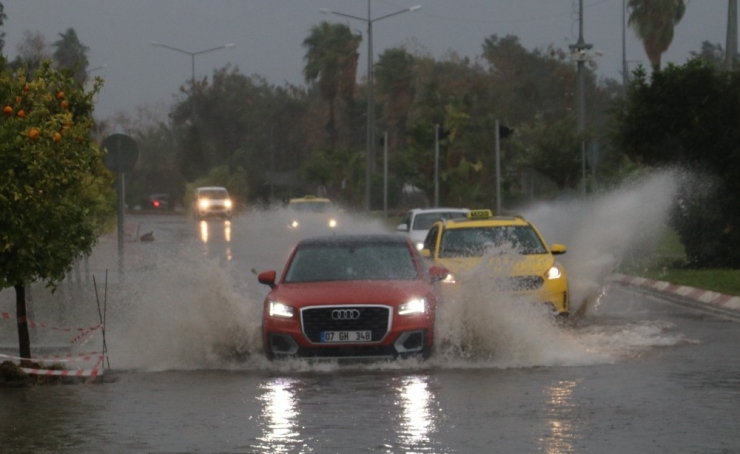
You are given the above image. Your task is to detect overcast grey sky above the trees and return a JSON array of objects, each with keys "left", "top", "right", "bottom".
[{"left": 2, "top": 0, "right": 727, "bottom": 118}]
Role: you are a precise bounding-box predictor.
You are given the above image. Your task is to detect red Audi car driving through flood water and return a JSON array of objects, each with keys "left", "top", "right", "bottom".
[{"left": 258, "top": 234, "right": 448, "bottom": 359}]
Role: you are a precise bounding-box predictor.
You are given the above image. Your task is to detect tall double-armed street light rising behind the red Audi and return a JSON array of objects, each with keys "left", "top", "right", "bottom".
[{"left": 320, "top": 0, "right": 421, "bottom": 211}]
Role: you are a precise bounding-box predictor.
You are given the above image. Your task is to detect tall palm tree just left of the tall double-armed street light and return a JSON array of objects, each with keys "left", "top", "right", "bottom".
[{"left": 303, "top": 21, "right": 362, "bottom": 147}]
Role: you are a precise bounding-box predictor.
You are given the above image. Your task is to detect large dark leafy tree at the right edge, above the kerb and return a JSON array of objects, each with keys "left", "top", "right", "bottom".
[{"left": 614, "top": 59, "right": 740, "bottom": 268}]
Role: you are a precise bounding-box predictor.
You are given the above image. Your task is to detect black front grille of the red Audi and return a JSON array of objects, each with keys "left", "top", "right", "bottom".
[{"left": 301, "top": 306, "right": 391, "bottom": 343}]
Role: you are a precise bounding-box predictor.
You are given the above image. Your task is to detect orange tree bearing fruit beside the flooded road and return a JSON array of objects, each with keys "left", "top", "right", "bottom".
[{"left": 0, "top": 58, "right": 115, "bottom": 358}]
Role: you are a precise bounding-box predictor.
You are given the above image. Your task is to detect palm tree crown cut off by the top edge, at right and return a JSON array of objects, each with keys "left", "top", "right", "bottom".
[{"left": 627, "top": 0, "right": 686, "bottom": 69}]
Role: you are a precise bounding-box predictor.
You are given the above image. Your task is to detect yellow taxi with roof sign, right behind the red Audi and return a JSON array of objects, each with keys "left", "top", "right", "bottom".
[{"left": 421, "top": 210, "right": 570, "bottom": 315}]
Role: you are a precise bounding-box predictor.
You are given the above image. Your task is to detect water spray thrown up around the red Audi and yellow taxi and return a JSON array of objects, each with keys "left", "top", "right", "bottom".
[{"left": 92, "top": 172, "right": 682, "bottom": 371}]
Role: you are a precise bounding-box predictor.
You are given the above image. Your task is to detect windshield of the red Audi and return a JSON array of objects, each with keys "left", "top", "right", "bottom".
[{"left": 284, "top": 243, "right": 418, "bottom": 283}]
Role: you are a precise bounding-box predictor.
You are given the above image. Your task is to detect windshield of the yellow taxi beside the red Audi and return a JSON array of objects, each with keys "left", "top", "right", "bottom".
[{"left": 439, "top": 226, "right": 547, "bottom": 257}]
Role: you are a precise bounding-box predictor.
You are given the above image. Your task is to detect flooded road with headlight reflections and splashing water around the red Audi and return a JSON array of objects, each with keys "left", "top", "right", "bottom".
[{"left": 0, "top": 205, "right": 740, "bottom": 453}]
